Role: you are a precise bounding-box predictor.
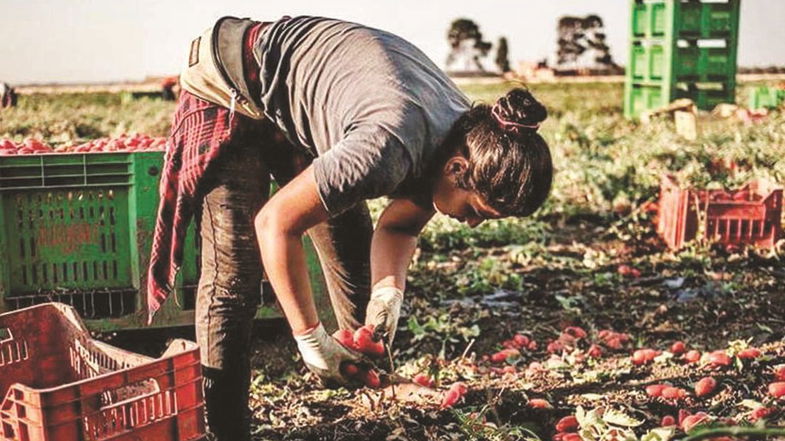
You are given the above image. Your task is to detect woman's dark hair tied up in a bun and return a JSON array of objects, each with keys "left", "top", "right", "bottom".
[{"left": 439, "top": 88, "right": 553, "bottom": 216}]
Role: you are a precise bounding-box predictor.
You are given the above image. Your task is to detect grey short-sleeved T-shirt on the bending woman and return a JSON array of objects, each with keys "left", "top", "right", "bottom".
[{"left": 254, "top": 16, "right": 470, "bottom": 215}]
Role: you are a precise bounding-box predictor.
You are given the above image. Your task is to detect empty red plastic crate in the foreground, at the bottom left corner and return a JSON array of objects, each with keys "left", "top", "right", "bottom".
[{"left": 0, "top": 303, "right": 206, "bottom": 441}]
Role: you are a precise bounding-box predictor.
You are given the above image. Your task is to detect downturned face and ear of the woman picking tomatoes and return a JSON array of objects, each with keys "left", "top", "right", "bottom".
[{"left": 433, "top": 155, "right": 503, "bottom": 228}]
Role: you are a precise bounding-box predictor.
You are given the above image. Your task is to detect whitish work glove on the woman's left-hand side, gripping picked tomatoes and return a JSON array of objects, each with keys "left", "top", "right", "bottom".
[{"left": 294, "top": 323, "right": 362, "bottom": 387}]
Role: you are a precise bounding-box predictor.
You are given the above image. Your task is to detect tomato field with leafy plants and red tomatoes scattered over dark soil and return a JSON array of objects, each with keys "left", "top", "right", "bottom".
[{"left": 0, "top": 83, "right": 785, "bottom": 441}]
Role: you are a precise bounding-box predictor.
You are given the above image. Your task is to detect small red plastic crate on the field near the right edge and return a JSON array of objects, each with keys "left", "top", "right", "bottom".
[{"left": 657, "top": 176, "right": 782, "bottom": 250}]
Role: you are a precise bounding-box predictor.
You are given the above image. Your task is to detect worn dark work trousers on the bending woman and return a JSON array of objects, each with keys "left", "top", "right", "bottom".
[{"left": 195, "top": 119, "right": 372, "bottom": 441}]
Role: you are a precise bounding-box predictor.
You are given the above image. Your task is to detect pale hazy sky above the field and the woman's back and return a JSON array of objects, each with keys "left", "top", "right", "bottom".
[{"left": 0, "top": 0, "right": 785, "bottom": 84}]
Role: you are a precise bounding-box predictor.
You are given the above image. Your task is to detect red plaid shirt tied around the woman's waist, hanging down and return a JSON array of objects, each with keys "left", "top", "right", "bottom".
[{"left": 147, "top": 23, "right": 263, "bottom": 324}]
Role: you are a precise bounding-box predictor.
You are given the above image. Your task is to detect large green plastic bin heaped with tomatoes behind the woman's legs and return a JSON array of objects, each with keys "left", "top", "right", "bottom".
[{"left": 0, "top": 152, "right": 331, "bottom": 330}]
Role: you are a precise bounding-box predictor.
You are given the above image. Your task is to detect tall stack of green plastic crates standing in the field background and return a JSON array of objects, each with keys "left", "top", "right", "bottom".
[{"left": 624, "top": 0, "right": 741, "bottom": 118}]
